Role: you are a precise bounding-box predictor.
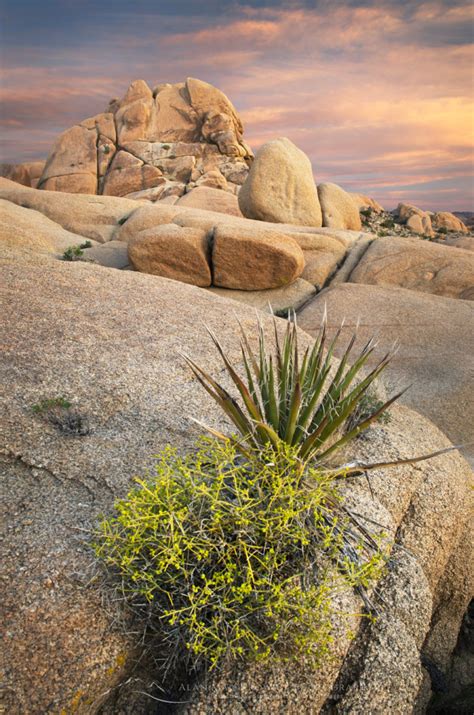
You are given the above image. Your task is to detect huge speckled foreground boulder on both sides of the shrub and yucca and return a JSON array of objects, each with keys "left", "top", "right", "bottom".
[{"left": 0, "top": 253, "right": 470, "bottom": 715}]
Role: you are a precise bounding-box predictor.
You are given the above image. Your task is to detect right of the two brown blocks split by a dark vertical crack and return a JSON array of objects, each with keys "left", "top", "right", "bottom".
[{"left": 212, "top": 226, "right": 304, "bottom": 290}]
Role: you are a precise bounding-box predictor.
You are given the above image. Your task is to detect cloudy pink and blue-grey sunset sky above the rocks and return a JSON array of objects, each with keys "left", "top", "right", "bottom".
[{"left": 0, "top": 0, "right": 474, "bottom": 210}]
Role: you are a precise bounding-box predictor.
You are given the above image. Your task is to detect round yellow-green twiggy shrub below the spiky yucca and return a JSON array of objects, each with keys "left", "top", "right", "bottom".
[{"left": 94, "top": 439, "right": 384, "bottom": 669}]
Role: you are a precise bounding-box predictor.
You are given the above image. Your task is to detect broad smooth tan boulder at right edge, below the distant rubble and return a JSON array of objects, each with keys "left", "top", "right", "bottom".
[{"left": 349, "top": 236, "right": 474, "bottom": 300}]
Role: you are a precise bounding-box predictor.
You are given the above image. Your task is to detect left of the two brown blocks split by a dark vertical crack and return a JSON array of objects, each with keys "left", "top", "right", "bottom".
[{"left": 128, "top": 224, "right": 211, "bottom": 287}]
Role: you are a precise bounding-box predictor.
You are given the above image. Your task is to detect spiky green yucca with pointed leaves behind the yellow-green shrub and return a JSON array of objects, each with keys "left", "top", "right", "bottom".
[{"left": 184, "top": 318, "right": 402, "bottom": 464}]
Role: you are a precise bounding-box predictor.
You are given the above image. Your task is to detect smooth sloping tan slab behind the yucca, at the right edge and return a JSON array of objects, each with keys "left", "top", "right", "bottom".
[{"left": 298, "top": 283, "right": 474, "bottom": 468}]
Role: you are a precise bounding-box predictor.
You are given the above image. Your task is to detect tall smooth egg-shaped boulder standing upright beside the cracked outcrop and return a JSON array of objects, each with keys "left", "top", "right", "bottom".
[{"left": 239, "top": 138, "right": 322, "bottom": 226}]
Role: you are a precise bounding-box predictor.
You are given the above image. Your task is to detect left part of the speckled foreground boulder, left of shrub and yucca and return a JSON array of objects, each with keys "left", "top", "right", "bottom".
[{"left": 0, "top": 261, "right": 320, "bottom": 715}]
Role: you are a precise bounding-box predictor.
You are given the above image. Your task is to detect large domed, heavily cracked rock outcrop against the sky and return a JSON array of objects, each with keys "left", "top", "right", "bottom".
[{"left": 38, "top": 78, "right": 252, "bottom": 201}]
